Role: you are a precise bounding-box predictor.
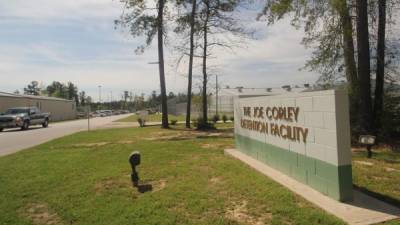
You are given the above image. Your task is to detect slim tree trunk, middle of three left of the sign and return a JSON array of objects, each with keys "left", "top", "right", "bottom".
[{"left": 186, "top": 0, "right": 196, "bottom": 128}]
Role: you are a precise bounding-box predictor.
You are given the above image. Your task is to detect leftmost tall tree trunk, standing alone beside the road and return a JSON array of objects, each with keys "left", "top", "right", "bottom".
[{"left": 157, "top": 0, "right": 169, "bottom": 128}]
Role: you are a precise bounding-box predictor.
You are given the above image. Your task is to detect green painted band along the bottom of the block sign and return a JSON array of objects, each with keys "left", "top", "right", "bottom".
[{"left": 235, "top": 134, "right": 353, "bottom": 201}]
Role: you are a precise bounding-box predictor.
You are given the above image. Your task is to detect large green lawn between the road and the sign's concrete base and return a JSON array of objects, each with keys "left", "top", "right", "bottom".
[{"left": 0, "top": 125, "right": 343, "bottom": 225}]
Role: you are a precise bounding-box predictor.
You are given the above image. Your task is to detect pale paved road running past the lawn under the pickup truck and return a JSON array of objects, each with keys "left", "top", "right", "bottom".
[{"left": 0, "top": 114, "right": 134, "bottom": 156}]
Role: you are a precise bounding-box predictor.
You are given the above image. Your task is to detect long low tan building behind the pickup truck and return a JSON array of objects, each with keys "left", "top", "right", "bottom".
[{"left": 0, "top": 92, "right": 76, "bottom": 121}]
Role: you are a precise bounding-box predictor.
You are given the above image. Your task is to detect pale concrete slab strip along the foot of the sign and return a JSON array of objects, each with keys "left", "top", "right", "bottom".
[{"left": 225, "top": 149, "right": 400, "bottom": 225}]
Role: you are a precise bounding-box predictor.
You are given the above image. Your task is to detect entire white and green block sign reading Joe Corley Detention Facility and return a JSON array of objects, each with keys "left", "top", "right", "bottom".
[{"left": 234, "top": 90, "right": 353, "bottom": 201}]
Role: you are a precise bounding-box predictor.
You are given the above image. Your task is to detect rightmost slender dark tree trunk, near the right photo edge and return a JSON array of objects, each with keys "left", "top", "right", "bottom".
[{"left": 374, "top": 0, "right": 386, "bottom": 132}]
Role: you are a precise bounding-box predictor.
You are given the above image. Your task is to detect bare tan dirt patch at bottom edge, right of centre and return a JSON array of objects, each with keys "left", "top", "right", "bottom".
[{"left": 225, "top": 201, "right": 272, "bottom": 225}]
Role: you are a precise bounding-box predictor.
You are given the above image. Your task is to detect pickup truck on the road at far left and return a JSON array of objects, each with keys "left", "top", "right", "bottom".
[{"left": 0, "top": 107, "right": 50, "bottom": 132}]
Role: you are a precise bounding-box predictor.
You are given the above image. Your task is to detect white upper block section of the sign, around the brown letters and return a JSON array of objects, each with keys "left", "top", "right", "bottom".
[{"left": 235, "top": 90, "right": 351, "bottom": 166}]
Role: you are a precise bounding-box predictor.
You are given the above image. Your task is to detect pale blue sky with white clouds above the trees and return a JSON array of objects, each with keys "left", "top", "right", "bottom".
[{"left": 0, "top": 0, "right": 318, "bottom": 101}]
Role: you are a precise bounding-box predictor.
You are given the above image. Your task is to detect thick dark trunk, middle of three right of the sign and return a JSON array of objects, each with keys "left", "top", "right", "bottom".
[{"left": 357, "top": 0, "right": 373, "bottom": 133}]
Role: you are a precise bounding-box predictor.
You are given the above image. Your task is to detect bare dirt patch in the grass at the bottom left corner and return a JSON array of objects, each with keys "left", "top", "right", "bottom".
[{"left": 21, "top": 203, "right": 64, "bottom": 225}]
